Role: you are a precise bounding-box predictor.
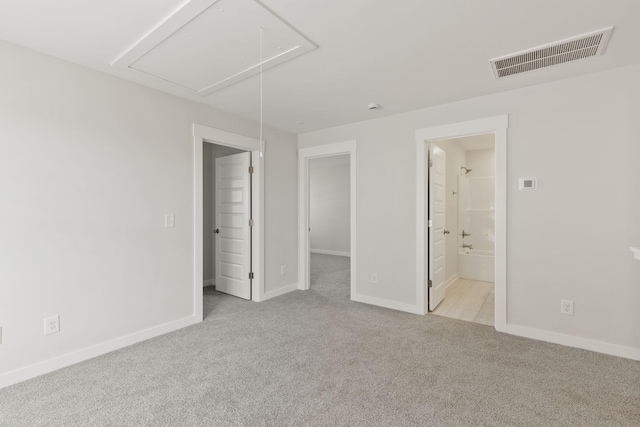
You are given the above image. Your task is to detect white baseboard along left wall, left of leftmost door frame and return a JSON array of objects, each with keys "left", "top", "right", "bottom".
[{"left": 0, "top": 315, "right": 198, "bottom": 388}]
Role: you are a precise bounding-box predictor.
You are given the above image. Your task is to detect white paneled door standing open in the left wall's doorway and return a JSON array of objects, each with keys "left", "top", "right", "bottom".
[{"left": 214, "top": 152, "right": 251, "bottom": 299}]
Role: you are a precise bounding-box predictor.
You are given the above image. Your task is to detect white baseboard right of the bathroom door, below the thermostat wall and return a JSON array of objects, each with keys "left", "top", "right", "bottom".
[{"left": 505, "top": 324, "right": 640, "bottom": 360}]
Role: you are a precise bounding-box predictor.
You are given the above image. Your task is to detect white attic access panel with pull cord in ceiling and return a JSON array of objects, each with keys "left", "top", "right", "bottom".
[{"left": 112, "top": 0, "right": 317, "bottom": 96}]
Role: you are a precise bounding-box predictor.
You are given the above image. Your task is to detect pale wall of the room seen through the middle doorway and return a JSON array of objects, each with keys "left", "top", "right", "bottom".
[{"left": 309, "top": 155, "right": 350, "bottom": 256}]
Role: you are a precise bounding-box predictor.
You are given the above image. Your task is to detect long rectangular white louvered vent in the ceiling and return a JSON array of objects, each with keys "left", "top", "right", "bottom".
[{"left": 490, "top": 27, "right": 613, "bottom": 79}]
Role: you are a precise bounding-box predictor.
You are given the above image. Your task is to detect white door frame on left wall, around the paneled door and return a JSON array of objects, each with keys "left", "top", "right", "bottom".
[{"left": 193, "top": 123, "right": 264, "bottom": 322}]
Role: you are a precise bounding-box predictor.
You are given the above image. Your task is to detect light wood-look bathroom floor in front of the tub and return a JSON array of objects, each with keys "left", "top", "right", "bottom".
[{"left": 433, "top": 279, "right": 495, "bottom": 326}]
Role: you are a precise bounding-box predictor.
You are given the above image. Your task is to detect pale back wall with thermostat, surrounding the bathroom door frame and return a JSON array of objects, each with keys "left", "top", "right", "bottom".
[{"left": 298, "top": 66, "right": 640, "bottom": 358}]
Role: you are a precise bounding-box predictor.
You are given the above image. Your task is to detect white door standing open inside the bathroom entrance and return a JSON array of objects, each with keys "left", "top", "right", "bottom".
[{"left": 429, "top": 144, "right": 446, "bottom": 311}]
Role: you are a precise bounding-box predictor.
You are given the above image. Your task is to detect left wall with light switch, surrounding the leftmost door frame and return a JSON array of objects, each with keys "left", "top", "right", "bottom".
[{"left": 0, "top": 42, "right": 297, "bottom": 386}]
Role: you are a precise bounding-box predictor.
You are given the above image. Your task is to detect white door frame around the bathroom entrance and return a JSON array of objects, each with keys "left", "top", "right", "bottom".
[{"left": 416, "top": 114, "right": 509, "bottom": 332}]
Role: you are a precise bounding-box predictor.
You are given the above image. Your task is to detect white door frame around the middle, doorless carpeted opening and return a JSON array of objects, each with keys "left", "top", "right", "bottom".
[{"left": 298, "top": 141, "right": 358, "bottom": 299}]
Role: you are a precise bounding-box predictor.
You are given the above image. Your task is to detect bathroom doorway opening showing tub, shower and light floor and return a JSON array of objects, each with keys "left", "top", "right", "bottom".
[{"left": 428, "top": 133, "right": 496, "bottom": 326}]
